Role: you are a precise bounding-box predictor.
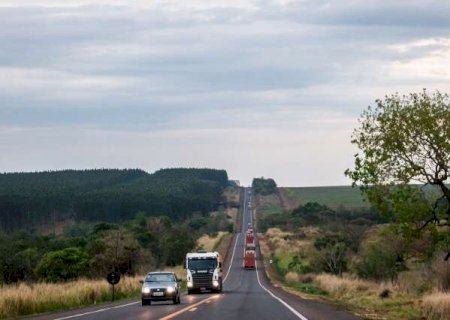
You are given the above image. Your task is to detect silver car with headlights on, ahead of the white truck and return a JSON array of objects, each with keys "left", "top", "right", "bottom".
[{"left": 142, "top": 271, "right": 181, "bottom": 306}]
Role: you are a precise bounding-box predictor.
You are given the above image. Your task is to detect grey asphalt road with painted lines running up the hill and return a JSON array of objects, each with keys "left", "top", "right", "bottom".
[{"left": 29, "top": 188, "right": 359, "bottom": 320}]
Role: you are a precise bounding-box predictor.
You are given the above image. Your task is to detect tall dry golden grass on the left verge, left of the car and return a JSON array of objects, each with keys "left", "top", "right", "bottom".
[{"left": 0, "top": 276, "right": 143, "bottom": 319}]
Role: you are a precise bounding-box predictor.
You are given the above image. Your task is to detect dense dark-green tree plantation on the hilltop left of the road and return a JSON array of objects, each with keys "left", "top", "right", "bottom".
[{"left": 0, "top": 168, "right": 228, "bottom": 232}]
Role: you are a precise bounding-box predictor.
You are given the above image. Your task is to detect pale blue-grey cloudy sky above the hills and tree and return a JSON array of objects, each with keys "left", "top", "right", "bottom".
[{"left": 0, "top": 0, "right": 450, "bottom": 187}]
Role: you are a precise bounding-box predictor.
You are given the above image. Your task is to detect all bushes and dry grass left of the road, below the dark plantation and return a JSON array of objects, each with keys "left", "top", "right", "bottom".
[{"left": 0, "top": 182, "right": 239, "bottom": 318}]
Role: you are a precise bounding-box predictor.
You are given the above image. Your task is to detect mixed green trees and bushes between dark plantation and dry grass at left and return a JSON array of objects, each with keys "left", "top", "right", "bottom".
[{"left": 0, "top": 211, "right": 233, "bottom": 285}]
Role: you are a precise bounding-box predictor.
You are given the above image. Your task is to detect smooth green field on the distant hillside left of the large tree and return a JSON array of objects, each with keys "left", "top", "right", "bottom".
[{"left": 280, "top": 186, "right": 369, "bottom": 209}]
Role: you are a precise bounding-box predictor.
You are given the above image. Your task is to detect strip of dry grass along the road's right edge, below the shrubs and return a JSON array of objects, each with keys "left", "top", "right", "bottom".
[{"left": 259, "top": 228, "right": 426, "bottom": 320}]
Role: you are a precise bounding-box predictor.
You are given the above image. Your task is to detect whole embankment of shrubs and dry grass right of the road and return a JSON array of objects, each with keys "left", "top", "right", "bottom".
[{"left": 256, "top": 178, "right": 450, "bottom": 320}]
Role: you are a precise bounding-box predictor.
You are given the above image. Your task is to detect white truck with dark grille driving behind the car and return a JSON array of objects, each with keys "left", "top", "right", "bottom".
[{"left": 185, "top": 251, "right": 222, "bottom": 294}]
